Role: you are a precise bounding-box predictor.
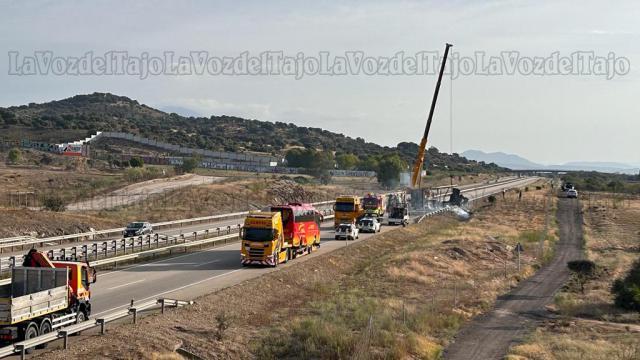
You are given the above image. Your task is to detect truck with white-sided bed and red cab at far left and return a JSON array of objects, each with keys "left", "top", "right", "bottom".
[{"left": 0, "top": 249, "right": 96, "bottom": 353}]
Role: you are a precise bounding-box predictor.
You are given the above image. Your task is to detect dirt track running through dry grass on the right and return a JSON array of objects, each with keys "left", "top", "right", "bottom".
[{"left": 445, "top": 199, "right": 583, "bottom": 360}]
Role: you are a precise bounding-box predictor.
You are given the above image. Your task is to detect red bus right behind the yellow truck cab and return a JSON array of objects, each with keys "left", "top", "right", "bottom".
[{"left": 271, "top": 203, "right": 323, "bottom": 259}]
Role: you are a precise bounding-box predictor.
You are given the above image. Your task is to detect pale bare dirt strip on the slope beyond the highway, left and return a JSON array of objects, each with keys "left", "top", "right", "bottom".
[{"left": 67, "top": 174, "right": 222, "bottom": 211}]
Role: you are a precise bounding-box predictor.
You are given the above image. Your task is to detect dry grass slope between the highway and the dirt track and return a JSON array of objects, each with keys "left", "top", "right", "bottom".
[{"left": 47, "top": 184, "right": 556, "bottom": 359}]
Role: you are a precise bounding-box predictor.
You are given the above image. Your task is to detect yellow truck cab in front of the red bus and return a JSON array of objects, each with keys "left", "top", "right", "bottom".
[{"left": 240, "top": 211, "right": 289, "bottom": 267}]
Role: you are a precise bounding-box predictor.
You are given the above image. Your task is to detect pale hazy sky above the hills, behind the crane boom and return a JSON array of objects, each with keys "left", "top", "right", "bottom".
[{"left": 0, "top": 0, "right": 640, "bottom": 164}]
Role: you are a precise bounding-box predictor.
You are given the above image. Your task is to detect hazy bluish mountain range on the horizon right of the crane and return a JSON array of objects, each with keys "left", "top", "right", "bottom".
[{"left": 462, "top": 150, "right": 640, "bottom": 174}]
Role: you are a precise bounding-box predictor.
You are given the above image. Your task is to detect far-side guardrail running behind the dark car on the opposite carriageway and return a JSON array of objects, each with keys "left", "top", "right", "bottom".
[{"left": 0, "top": 200, "right": 335, "bottom": 253}]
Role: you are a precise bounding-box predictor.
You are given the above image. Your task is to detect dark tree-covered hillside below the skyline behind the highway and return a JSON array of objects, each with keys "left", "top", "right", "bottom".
[{"left": 0, "top": 93, "right": 500, "bottom": 172}]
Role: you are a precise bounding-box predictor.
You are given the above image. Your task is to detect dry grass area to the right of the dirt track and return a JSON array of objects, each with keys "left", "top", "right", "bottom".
[{"left": 511, "top": 194, "right": 640, "bottom": 360}]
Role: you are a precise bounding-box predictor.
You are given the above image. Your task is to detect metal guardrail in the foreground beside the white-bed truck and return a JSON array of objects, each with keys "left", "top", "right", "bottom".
[{"left": 0, "top": 298, "right": 194, "bottom": 360}]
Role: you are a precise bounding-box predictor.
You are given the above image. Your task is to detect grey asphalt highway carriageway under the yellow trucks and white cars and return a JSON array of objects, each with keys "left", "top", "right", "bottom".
[{"left": 86, "top": 178, "right": 537, "bottom": 317}]
